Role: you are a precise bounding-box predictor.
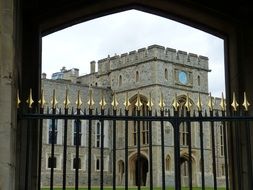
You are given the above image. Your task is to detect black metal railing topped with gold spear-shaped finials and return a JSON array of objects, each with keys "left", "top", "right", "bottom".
[{"left": 19, "top": 90, "right": 253, "bottom": 190}]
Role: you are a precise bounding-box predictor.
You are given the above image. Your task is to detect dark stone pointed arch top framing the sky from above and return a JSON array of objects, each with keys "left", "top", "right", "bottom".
[{"left": 39, "top": 0, "right": 233, "bottom": 37}]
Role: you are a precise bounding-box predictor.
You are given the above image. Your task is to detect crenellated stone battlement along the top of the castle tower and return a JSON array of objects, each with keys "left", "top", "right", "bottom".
[{"left": 94, "top": 45, "right": 208, "bottom": 74}]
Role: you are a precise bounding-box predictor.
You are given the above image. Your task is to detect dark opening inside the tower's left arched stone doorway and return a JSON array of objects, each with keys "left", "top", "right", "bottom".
[{"left": 135, "top": 156, "right": 148, "bottom": 186}]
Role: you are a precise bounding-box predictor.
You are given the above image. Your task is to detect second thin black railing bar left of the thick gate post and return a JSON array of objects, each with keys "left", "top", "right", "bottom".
[{"left": 148, "top": 110, "right": 153, "bottom": 190}]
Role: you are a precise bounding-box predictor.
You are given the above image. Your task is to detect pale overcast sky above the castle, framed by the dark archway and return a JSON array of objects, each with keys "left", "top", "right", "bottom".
[{"left": 42, "top": 10, "right": 225, "bottom": 97}]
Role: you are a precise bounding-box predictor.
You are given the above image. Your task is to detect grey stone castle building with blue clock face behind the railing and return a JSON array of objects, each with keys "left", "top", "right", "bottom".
[{"left": 41, "top": 45, "right": 225, "bottom": 186}]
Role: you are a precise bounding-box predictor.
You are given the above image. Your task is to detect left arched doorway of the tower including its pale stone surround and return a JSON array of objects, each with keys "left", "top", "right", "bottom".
[{"left": 129, "top": 153, "right": 148, "bottom": 186}]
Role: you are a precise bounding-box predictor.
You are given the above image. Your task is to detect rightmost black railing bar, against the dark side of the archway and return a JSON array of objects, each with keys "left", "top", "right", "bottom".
[{"left": 244, "top": 111, "right": 253, "bottom": 189}]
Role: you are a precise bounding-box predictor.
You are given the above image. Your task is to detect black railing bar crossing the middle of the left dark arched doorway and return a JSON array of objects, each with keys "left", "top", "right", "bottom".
[{"left": 137, "top": 110, "right": 141, "bottom": 190}]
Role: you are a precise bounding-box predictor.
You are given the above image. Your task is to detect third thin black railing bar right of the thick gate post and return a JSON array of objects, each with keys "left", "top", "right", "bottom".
[{"left": 210, "top": 111, "right": 217, "bottom": 190}]
